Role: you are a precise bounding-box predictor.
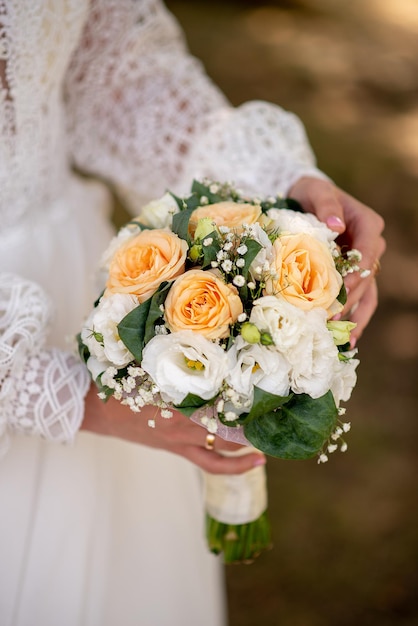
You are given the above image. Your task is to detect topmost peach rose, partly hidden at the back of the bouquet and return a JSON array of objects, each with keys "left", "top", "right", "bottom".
[{"left": 189, "top": 201, "right": 262, "bottom": 236}]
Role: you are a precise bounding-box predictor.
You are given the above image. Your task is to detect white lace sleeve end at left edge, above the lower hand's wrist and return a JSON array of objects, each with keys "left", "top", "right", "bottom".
[{"left": 0, "top": 274, "right": 89, "bottom": 455}]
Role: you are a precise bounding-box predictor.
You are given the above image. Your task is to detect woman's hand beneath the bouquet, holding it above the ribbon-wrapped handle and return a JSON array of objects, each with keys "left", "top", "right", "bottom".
[{"left": 81, "top": 384, "right": 266, "bottom": 474}]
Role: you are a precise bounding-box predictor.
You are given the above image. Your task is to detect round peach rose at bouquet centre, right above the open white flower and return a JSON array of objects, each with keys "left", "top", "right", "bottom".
[{"left": 165, "top": 270, "right": 243, "bottom": 339}]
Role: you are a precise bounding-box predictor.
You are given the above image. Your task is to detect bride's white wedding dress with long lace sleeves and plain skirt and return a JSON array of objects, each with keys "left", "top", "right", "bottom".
[{"left": 0, "top": 0, "right": 321, "bottom": 626}]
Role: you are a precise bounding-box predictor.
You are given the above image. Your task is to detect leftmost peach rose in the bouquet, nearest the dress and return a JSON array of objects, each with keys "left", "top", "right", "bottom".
[{"left": 106, "top": 229, "right": 188, "bottom": 302}]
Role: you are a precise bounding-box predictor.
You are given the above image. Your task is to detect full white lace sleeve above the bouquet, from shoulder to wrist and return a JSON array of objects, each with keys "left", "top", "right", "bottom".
[{"left": 66, "top": 0, "right": 323, "bottom": 207}]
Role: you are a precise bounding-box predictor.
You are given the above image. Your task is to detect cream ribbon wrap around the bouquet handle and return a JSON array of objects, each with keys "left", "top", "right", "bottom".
[{"left": 204, "top": 446, "right": 267, "bottom": 524}]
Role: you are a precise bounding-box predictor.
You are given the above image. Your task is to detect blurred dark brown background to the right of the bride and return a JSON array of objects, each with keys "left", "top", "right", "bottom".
[{"left": 166, "top": 0, "right": 418, "bottom": 626}]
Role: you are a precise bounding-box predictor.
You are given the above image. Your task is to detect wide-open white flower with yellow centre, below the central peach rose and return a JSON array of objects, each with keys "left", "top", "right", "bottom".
[{"left": 141, "top": 330, "right": 228, "bottom": 404}]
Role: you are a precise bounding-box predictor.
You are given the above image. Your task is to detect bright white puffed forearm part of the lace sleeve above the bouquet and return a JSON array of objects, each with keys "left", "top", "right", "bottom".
[{"left": 178, "top": 101, "right": 326, "bottom": 196}]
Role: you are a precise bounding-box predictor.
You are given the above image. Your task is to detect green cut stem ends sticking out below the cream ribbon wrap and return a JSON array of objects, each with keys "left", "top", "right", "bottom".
[{"left": 206, "top": 511, "right": 271, "bottom": 563}]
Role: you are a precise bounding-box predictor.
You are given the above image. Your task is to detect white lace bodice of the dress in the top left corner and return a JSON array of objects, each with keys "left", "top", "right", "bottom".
[{"left": 0, "top": 0, "right": 88, "bottom": 233}]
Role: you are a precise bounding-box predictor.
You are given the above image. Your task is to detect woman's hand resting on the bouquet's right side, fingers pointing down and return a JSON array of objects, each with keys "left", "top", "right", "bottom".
[{"left": 288, "top": 177, "right": 386, "bottom": 347}]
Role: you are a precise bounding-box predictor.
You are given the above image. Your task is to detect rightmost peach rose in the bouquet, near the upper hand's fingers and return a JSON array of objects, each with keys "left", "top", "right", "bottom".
[{"left": 264, "top": 233, "right": 342, "bottom": 317}]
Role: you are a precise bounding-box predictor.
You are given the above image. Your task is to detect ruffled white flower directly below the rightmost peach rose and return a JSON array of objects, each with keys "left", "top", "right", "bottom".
[{"left": 287, "top": 309, "right": 339, "bottom": 398}]
